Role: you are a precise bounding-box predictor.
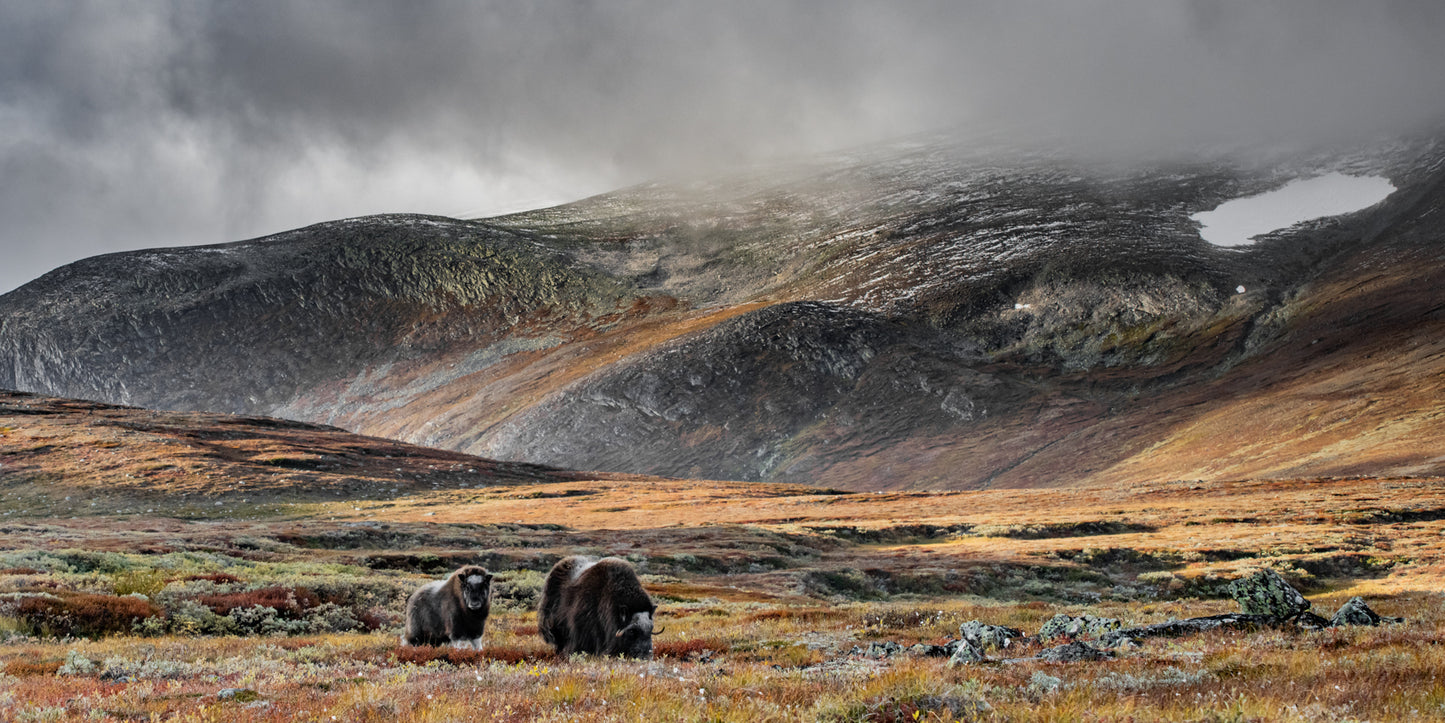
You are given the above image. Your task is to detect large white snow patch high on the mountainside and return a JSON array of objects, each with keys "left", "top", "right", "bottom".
[{"left": 1189, "top": 174, "right": 1394, "bottom": 246}]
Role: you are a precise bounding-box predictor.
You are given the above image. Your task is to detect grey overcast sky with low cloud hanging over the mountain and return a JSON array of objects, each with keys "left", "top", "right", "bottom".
[{"left": 0, "top": 0, "right": 1445, "bottom": 292}]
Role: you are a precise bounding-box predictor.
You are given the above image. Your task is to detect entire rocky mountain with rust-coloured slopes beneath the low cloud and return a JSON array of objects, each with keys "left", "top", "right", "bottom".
[{"left": 0, "top": 133, "right": 1445, "bottom": 489}]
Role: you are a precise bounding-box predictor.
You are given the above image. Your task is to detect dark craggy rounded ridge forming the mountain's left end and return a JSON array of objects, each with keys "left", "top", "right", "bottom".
[{"left": 0, "top": 215, "right": 639, "bottom": 414}]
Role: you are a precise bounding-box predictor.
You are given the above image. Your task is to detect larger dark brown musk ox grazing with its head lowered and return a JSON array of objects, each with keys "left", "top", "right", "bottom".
[{"left": 538, "top": 557, "right": 662, "bottom": 658}]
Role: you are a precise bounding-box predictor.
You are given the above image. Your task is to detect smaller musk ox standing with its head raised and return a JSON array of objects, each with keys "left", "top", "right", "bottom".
[{"left": 402, "top": 565, "right": 491, "bottom": 651}]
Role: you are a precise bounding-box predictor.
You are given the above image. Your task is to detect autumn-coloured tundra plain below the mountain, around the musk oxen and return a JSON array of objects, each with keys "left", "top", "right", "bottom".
[{"left": 0, "top": 393, "right": 1445, "bottom": 723}]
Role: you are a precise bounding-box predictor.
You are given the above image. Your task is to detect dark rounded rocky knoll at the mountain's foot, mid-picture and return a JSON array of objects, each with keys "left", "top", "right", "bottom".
[{"left": 477, "top": 302, "right": 1027, "bottom": 480}]
